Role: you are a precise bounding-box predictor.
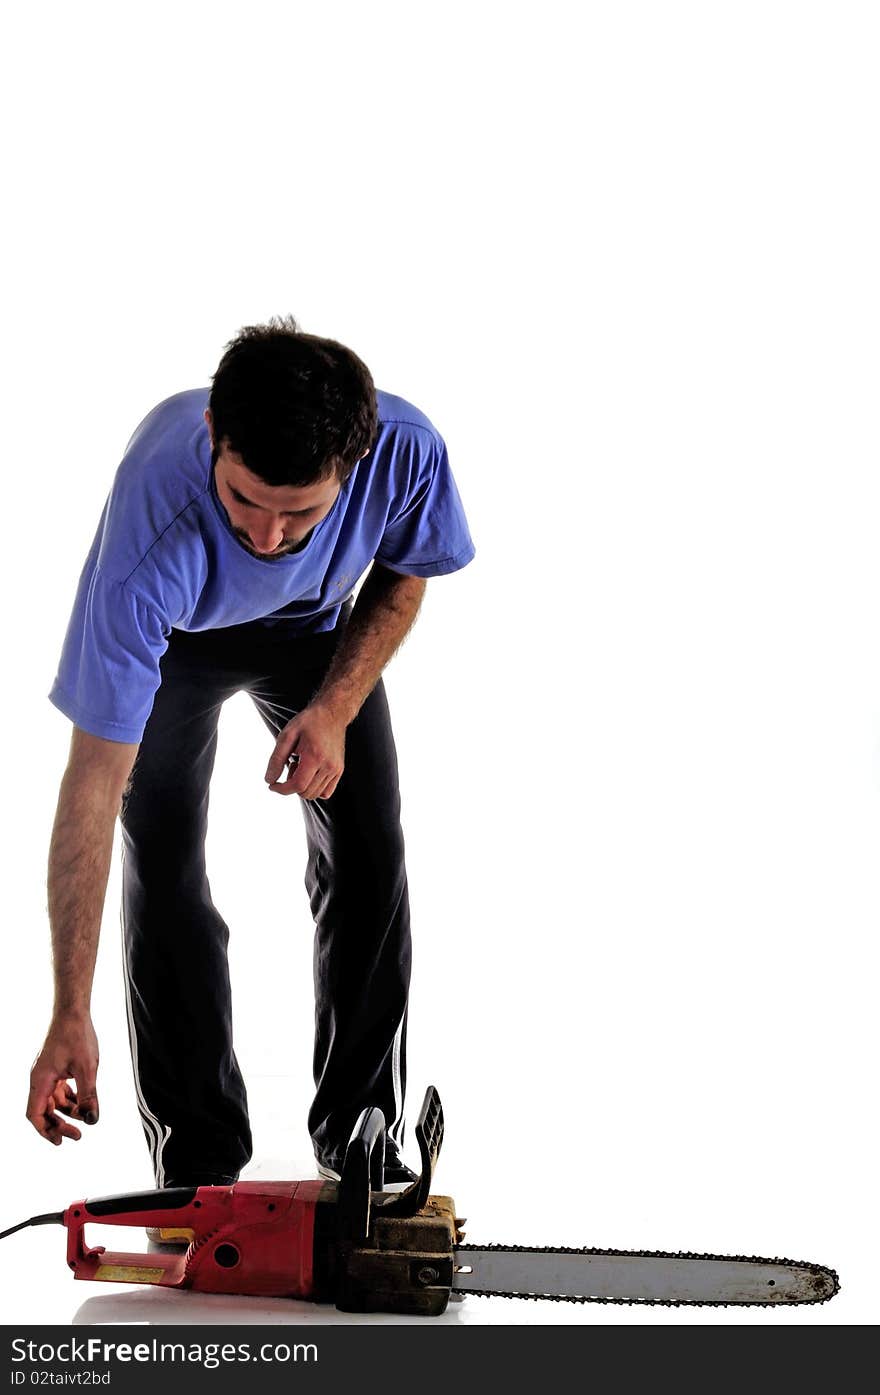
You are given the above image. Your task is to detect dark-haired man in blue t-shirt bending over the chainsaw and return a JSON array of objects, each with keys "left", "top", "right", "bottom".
[{"left": 28, "top": 318, "right": 474, "bottom": 1187}]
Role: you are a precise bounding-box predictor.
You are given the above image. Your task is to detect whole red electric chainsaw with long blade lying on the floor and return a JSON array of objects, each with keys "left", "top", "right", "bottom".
[{"left": 0, "top": 1087, "right": 840, "bottom": 1315}]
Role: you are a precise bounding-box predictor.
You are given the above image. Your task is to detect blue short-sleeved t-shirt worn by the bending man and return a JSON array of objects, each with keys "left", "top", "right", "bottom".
[{"left": 49, "top": 388, "right": 474, "bottom": 742}]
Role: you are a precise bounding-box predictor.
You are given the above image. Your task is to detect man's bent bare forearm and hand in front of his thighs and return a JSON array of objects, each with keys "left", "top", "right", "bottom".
[{"left": 265, "top": 562, "right": 427, "bottom": 799}]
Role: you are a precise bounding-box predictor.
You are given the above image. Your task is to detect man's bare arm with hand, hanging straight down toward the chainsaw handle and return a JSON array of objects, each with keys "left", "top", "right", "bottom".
[{"left": 26, "top": 727, "right": 138, "bottom": 1144}]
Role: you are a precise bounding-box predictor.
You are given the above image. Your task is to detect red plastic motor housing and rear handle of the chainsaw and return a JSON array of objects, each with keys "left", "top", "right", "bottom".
[{"left": 64, "top": 1180, "right": 325, "bottom": 1299}]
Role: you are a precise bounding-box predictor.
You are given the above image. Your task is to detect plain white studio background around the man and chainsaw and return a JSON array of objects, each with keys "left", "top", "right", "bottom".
[{"left": 0, "top": 0, "right": 880, "bottom": 1325}]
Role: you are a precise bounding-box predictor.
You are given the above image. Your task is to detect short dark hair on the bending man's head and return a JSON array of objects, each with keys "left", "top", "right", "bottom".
[{"left": 208, "top": 315, "right": 377, "bottom": 485}]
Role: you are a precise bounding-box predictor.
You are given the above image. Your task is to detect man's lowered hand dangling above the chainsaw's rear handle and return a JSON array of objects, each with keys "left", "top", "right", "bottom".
[{"left": 26, "top": 1014, "right": 98, "bottom": 1144}]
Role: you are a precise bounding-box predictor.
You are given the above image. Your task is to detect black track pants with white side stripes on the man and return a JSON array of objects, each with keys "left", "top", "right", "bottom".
[{"left": 121, "top": 622, "right": 410, "bottom": 1186}]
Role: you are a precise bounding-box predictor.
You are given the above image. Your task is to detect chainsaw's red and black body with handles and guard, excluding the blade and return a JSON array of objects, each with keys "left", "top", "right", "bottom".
[{"left": 50, "top": 1087, "right": 460, "bottom": 1315}]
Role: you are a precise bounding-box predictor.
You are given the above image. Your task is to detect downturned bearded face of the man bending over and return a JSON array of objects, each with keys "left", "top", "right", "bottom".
[{"left": 205, "top": 410, "right": 340, "bottom": 559}]
